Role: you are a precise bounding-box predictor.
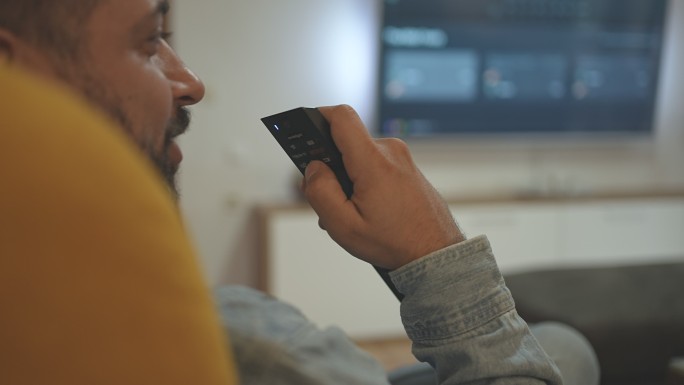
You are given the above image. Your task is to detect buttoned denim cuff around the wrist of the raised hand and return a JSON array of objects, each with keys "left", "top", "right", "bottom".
[{"left": 390, "top": 236, "right": 515, "bottom": 343}]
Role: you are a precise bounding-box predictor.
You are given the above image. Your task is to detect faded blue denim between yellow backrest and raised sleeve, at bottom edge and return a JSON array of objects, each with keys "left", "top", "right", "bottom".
[{"left": 215, "top": 286, "right": 387, "bottom": 385}]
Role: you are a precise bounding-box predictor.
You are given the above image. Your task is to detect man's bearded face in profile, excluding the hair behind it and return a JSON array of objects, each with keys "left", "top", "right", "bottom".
[{"left": 18, "top": 0, "right": 204, "bottom": 196}]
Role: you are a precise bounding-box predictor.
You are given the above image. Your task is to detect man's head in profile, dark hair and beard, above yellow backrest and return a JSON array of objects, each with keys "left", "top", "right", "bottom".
[{"left": 0, "top": 0, "right": 204, "bottom": 198}]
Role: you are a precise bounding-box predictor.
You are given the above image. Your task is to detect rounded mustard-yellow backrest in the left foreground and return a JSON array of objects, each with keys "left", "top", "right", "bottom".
[{"left": 0, "top": 67, "right": 236, "bottom": 385}]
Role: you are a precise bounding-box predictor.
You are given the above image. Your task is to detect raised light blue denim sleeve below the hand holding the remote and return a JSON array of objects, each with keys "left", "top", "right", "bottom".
[{"left": 391, "top": 236, "right": 562, "bottom": 385}]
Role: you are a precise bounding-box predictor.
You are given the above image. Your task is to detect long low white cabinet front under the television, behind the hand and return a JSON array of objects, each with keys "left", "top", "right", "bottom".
[{"left": 260, "top": 194, "right": 684, "bottom": 339}]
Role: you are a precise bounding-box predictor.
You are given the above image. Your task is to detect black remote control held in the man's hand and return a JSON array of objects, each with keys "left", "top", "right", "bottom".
[{"left": 261, "top": 107, "right": 404, "bottom": 301}]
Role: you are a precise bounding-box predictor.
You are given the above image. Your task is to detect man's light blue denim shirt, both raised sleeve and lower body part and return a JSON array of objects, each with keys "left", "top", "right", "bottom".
[{"left": 216, "top": 237, "right": 562, "bottom": 385}]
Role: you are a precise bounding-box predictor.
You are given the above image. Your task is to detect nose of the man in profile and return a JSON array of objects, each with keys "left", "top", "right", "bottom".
[{"left": 163, "top": 42, "right": 205, "bottom": 107}]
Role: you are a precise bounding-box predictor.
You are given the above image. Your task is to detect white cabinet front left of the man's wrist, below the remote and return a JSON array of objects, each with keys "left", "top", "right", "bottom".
[{"left": 265, "top": 210, "right": 404, "bottom": 339}]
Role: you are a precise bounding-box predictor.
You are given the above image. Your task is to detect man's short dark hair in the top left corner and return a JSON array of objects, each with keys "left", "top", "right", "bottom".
[{"left": 0, "top": 0, "right": 101, "bottom": 58}]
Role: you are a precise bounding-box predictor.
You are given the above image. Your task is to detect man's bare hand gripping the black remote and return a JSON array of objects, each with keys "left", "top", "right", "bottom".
[{"left": 302, "top": 106, "right": 464, "bottom": 269}]
